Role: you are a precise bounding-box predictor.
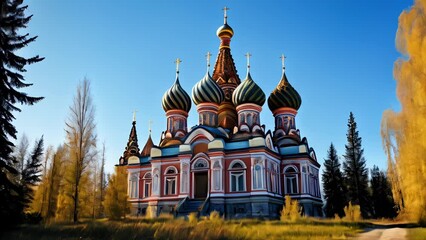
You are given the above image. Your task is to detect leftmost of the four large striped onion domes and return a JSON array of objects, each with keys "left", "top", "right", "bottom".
[{"left": 162, "top": 76, "right": 191, "bottom": 112}]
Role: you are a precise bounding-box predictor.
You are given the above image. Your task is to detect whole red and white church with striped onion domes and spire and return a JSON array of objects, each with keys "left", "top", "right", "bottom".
[{"left": 119, "top": 8, "right": 323, "bottom": 219}]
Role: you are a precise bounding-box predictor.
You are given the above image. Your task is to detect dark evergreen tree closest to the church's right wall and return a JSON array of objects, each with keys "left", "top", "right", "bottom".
[{"left": 322, "top": 143, "right": 346, "bottom": 218}]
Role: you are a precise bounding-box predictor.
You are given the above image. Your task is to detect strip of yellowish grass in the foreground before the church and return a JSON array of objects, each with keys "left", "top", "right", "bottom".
[{"left": 3, "top": 217, "right": 364, "bottom": 240}]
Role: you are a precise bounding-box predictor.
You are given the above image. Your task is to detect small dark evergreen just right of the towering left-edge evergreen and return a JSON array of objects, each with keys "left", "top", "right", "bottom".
[{"left": 21, "top": 137, "right": 43, "bottom": 208}]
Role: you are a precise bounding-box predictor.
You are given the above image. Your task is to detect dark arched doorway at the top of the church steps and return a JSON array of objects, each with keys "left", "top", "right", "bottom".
[{"left": 192, "top": 158, "right": 209, "bottom": 199}]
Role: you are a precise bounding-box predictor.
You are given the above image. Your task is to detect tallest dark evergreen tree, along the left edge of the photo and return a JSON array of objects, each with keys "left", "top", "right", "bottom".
[{"left": 0, "top": 0, "right": 43, "bottom": 224}]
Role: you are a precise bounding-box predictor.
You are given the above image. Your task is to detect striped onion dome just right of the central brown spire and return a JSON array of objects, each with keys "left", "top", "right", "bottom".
[{"left": 232, "top": 73, "right": 266, "bottom": 106}]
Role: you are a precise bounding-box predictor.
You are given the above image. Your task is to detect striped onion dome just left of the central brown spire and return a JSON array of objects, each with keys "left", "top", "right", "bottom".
[{"left": 192, "top": 72, "right": 225, "bottom": 105}]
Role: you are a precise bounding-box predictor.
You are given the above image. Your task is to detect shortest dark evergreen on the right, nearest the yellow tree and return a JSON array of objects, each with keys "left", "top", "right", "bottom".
[{"left": 370, "top": 166, "right": 396, "bottom": 218}]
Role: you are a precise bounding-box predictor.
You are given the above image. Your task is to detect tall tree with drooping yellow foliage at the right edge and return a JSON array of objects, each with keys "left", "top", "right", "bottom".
[{"left": 381, "top": 0, "right": 426, "bottom": 221}]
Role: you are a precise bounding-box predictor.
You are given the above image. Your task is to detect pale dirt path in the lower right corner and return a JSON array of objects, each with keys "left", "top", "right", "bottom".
[{"left": 355, "top": 227, "right": 407, "bottom": 240}]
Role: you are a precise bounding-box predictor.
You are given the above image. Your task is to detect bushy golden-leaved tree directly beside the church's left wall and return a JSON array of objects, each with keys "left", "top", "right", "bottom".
[{"left": 104, "top": 166, "right": 130, "bottom": 219}]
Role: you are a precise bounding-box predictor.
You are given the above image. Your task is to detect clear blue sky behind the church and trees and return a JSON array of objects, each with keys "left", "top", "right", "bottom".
[{"left": 14, "top": 0, "right": 413, "bottom": 172}]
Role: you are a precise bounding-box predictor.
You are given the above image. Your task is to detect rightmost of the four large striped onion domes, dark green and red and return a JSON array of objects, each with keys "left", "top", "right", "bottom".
[{"left": 268, "top": 73, "right": 302, "bottom": 112}]
